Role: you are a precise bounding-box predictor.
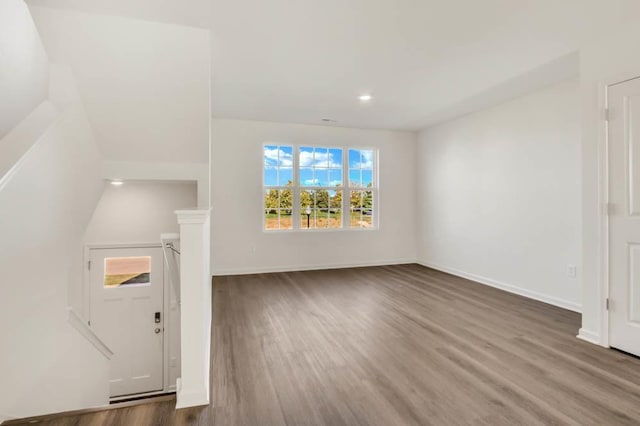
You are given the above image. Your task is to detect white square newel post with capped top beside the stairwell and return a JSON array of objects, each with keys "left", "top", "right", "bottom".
[{"left": 175, "top": 210, "right": 211, "bottom": 408}]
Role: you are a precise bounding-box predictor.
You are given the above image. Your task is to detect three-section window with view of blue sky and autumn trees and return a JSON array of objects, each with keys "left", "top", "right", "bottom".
[{"left": 263, "top": 144, "right": 377, "bottom": 231}]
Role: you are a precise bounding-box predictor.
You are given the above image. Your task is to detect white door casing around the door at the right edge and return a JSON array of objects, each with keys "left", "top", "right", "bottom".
[{"left": 596, "top": 70, "right": 640, "bottom": 348}]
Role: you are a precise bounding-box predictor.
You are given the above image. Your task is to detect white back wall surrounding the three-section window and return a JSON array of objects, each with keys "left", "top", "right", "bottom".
[{"left": 211, "top": 119, "right": 416, "bottom": 275}]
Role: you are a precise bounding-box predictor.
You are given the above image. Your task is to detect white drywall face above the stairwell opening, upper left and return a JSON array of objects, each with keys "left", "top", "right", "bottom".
[{"left": 31, "top": 6, "right": 211, "bottom": 164}]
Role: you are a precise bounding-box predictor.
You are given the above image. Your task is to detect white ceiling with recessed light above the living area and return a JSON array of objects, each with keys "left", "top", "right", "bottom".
[{"left": 29, "top": 0, "right": 640, "bottom": 130}]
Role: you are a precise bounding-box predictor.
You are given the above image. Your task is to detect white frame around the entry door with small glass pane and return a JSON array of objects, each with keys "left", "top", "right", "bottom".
[{"left": 82, "top": 243, "right": 176, "bottom": 402}]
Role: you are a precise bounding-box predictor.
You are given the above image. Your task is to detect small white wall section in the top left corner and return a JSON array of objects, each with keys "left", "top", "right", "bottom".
[{"left": 0, "top": 0, "right": 49, "bottom": 138}]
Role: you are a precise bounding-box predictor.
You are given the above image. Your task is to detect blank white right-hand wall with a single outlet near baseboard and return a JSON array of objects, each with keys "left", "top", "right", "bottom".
[{"left": 417, "top": 80, "right": 581, "bottom": 310}]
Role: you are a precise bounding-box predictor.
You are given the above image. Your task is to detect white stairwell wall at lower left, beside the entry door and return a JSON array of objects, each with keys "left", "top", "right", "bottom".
[{"left": 0, "top": 105, "right": 109, "bottom": 417}]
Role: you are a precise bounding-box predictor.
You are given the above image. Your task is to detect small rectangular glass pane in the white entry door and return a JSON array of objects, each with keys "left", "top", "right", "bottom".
[{"left": 104, "top": 256, "right": 151, "bottom": 288}]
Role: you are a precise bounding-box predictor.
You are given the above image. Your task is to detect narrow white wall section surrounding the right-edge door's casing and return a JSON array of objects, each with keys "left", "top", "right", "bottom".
[{"left": 580, "top": 22, "right": 640, "bottom": 346}]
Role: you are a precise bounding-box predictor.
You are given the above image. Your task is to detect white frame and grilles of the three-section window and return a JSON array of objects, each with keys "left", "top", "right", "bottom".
[{"left": 261, "top": 142, "right": 380, "bottom": 234}]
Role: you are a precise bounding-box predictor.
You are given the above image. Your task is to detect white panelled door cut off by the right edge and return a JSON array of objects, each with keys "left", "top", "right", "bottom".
[{"left": 608, "top": 78, "right": 640, "bottom": 355}]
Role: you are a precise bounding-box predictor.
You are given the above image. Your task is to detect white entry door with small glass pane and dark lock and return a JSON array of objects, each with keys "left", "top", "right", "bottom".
[{"left": 90, "top": 247, "right": 164, "bottom": 397}]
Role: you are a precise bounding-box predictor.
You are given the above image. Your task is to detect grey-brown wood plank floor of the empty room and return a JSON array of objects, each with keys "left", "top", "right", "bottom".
[{"left": 12, "top": 265, "right": 640, "bottom": 426}]
